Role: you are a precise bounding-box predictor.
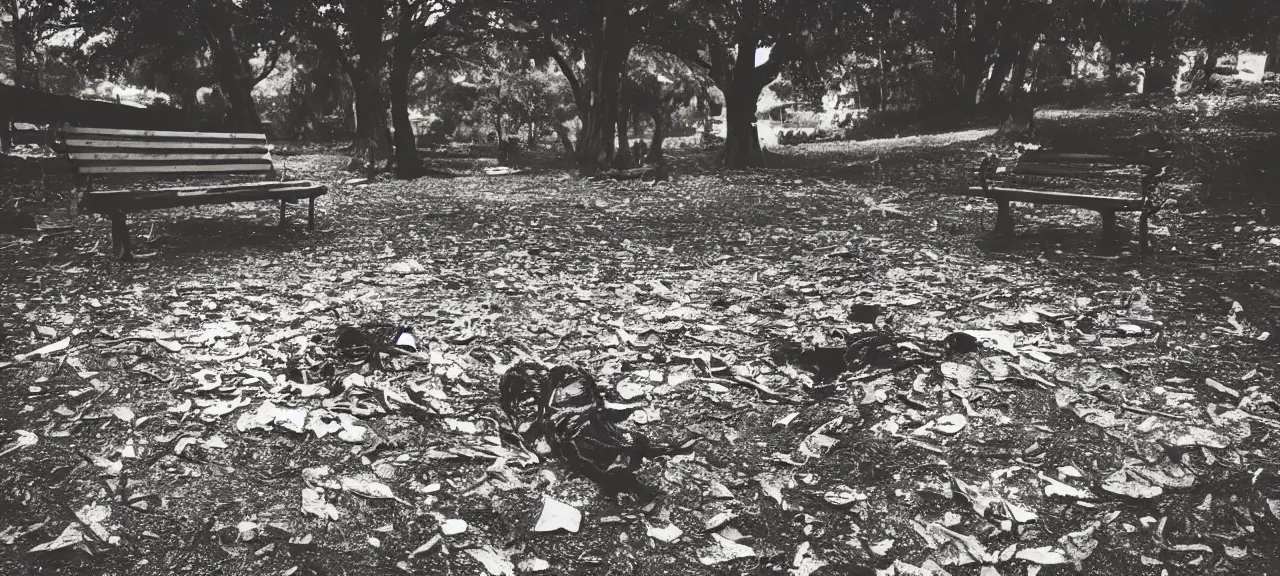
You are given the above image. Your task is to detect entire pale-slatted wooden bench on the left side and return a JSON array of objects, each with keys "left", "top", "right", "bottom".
[{"left": 59, "top": 128, "right": 326, "bottom": 260}]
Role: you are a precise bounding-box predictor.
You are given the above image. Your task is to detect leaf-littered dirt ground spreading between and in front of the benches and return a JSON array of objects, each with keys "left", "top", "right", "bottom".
[{"left": 0, "top": 95, "right": 1280, "bottom": 576}]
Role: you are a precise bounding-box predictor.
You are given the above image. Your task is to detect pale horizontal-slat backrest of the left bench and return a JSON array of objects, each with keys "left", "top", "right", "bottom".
[{"left": 60, "top": 128, "right": 275, "bottom": 177}]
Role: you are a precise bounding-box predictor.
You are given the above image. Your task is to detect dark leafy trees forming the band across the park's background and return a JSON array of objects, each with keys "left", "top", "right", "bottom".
[{"left": 0, "top": 0, "right": 1280, "bottom": 172}]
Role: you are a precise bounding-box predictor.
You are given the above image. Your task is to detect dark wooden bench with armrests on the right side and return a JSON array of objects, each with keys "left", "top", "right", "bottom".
[{"left": 965, "top": 150, "right": 1169, "bottom": 252}]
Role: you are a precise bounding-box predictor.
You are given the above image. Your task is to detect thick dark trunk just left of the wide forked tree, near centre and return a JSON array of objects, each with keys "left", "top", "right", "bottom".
[{"left": 577, "top": 0, "right": 631, "bottom": 174}]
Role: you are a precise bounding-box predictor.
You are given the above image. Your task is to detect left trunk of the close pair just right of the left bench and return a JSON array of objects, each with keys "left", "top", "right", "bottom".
[{"left": 347, "top": 0, "right": 392, "bottom": 175}]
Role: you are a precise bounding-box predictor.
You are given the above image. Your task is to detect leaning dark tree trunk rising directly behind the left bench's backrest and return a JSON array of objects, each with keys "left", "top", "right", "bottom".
[{"left": 197, "top": 0, "right": 262, "bottom": 133}]
